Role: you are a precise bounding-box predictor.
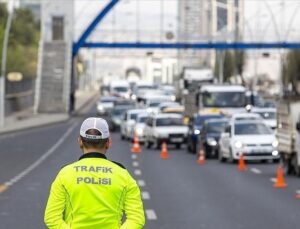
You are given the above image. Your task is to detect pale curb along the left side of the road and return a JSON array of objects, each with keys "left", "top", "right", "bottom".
[{"left": 0, "top": 92, "right": 98, "bottom": 136}]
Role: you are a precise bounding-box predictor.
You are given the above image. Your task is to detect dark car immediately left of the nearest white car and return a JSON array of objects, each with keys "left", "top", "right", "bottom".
[{"left": 199, "top": 119, "right": 228, "bottom": 158}]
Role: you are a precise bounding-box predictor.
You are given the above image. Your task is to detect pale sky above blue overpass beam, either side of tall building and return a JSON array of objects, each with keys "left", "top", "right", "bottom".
[{"left": 75, "top": 0, "right": 300, "bottom": 41}]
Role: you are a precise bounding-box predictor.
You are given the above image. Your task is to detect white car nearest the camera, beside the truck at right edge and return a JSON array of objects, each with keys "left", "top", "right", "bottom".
[{"left": 219, "top": 120, "right": 279, "bottom": 162}]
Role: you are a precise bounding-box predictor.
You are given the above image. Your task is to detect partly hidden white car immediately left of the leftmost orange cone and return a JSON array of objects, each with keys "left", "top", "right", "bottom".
[{"left": 120, "top": 109, "right": 146, "bottom": 139}]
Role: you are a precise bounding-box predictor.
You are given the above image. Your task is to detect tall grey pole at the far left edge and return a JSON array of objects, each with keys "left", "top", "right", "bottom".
[{"left": 0, "top": 0, "right": 15, "bottom": 127}]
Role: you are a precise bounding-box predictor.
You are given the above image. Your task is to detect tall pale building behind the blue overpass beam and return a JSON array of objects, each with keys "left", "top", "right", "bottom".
[{"left": 178, "top": 0, "right": 244, "bottom": 71}]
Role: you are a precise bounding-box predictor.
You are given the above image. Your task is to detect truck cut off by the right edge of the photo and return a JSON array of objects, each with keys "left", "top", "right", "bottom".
[{"left": 276, "top": 97, "right": 300, "bottom": 176}]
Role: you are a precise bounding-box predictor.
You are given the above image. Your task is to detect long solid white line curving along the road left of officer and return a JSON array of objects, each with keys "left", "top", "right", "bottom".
[{"left": 4, "top": 123, "right": 77, "bottom": 186}]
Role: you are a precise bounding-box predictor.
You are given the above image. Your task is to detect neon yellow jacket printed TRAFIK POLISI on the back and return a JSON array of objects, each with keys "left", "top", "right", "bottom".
[{"left": 44, "top": 153, "right": 145, "bottom": 229}]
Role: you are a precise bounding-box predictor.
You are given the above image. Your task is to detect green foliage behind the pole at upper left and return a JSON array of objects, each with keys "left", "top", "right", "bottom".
[{"left": 0, "top": 4, "right": 39, "bottom": 78}]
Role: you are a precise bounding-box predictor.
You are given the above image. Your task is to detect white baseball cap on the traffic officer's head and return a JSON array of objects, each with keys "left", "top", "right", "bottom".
[{"left": 80, "top": 117, "right": 109, "bottom": 140}]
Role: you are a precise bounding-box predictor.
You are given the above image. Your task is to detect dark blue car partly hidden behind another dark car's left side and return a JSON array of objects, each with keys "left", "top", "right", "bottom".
[{"left": 187, "top": 114, "right": 224, "bottom": 154}]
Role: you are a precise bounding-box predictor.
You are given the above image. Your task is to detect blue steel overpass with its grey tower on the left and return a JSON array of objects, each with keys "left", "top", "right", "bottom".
[{"left": 35, "top": 0, "right": 300, "bottom": 112}]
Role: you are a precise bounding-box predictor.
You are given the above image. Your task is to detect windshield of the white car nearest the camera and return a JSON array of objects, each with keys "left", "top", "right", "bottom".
[{"left": 234, "top": 123, "right": 272, "bottom": 135}]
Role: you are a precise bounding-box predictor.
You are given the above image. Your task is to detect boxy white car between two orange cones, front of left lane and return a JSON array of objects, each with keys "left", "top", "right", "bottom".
[{"left": 144, "top": 114, "right": 188, "bottom": 149}]
